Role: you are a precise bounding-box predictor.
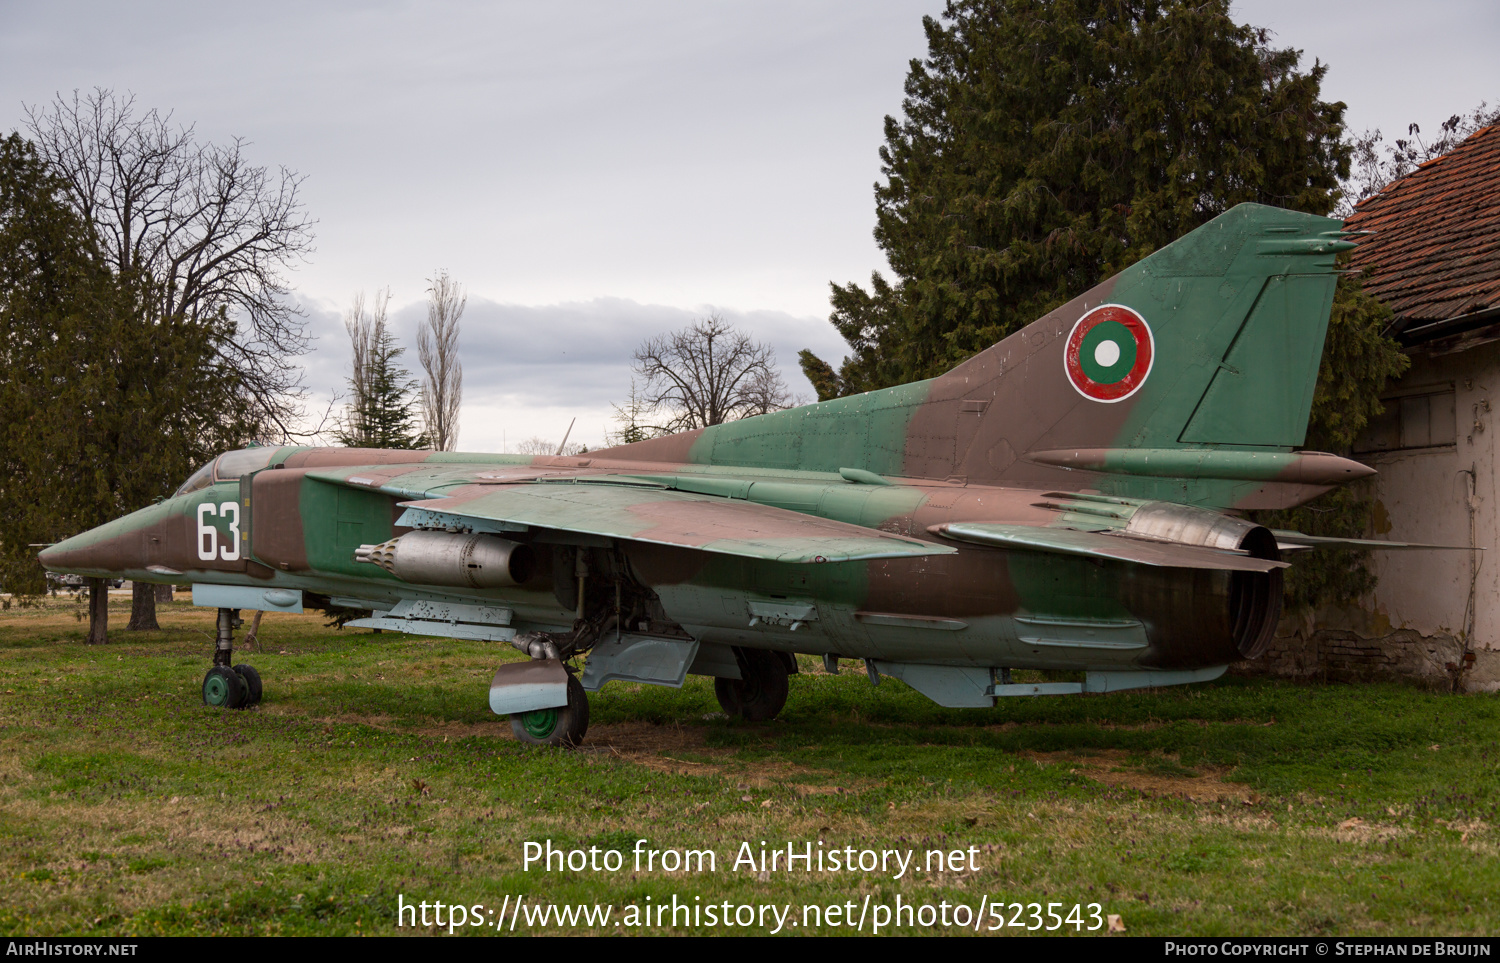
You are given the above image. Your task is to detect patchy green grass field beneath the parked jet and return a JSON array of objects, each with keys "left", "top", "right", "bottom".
[{"left": 0, "top": 596, "right": 1500, "bottom": 936}]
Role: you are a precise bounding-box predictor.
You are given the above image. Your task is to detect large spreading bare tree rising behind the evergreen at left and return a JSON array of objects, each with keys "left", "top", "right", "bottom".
[{"left": 26, "top": 87, "right": 314, "bottom": 437}]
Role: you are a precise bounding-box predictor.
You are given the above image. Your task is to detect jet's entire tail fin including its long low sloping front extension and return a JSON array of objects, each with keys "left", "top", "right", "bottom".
[{"left": 657, "top": 204, "right": 1352, "bottom": 507}]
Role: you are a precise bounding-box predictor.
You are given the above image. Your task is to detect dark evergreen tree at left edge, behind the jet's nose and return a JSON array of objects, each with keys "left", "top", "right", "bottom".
[{"left": 0, "top": 135, "right": 251, "bottom": 630}]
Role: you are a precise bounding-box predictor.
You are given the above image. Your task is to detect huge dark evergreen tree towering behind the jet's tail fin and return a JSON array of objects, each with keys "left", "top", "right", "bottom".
[{"left": 804, "top": 0, "right": 1349, "bottom": 398}]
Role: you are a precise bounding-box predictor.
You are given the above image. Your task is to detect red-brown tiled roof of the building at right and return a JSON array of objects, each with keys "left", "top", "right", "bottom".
[{"left": 1344, "top": 125, "right": 1500, "bottom": 330}]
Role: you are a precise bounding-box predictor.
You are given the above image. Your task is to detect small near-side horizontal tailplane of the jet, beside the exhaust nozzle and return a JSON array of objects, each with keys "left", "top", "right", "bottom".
[{"left": 927, "top": 522, "right": 1287, "bottom": 572}]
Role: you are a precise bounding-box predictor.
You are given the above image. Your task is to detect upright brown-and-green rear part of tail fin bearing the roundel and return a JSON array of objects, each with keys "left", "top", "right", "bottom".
[{"left": 909, "top": 204, "right": 1352, "bottom": 504}]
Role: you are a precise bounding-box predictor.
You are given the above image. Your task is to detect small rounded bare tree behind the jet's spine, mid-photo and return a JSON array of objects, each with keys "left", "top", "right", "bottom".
[{"left": 635, "top": 312, "right": 792, "bottom": 432}]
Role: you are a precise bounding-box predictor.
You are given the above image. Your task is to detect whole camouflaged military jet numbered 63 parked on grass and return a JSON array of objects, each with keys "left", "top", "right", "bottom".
[{"left": 42, "top": 204, "right": 1452, "bottom": 746}]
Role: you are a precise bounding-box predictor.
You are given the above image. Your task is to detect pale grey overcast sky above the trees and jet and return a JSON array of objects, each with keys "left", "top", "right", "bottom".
[{"left": 0, "top": 0, "right": 1500, "bottom": 450}]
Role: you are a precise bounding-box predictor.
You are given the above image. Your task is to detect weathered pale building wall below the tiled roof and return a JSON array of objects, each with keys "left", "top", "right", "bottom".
[{"left": 1263, "top": 342, "right": 1500, "bottom": 692}]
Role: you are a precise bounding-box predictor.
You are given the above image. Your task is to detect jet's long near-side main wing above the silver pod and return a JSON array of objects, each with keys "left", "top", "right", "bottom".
[{"left": 402, "top": 485, "right": 956, "bottom": 563}]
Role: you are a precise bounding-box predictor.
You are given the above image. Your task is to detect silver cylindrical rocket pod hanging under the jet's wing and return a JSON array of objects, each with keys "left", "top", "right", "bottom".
[{"left": 354, "top": 531, "right": 534, "bottom": 588}]
